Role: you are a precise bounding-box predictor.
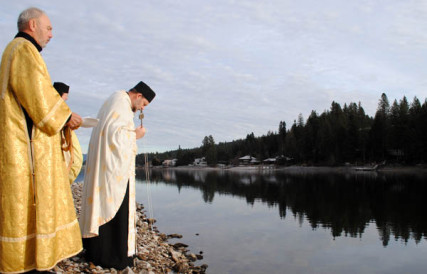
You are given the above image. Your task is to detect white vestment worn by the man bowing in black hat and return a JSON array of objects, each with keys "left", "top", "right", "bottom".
[{"left": 80, "top": 91, "right": 137, "bottom": 256}]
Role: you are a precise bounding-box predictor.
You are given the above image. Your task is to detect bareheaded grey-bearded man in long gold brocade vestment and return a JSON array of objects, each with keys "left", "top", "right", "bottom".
[{"left": 0, "top": 8, "right": 82, "bottom": 273}]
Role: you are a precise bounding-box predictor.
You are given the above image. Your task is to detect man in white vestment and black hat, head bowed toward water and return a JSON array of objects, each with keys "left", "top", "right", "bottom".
[{"left": 80, "top": 81, "right": 156, "bottom": 270}]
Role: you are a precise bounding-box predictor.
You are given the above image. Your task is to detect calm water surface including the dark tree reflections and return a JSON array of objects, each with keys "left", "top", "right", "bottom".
[{"left": 136, "top": 169, "right": 427, "bottom": 274}]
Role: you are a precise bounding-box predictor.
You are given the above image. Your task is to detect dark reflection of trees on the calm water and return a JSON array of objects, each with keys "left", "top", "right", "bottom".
[{"left": 136, "top": 170, "right": 427, "bottom": 246}]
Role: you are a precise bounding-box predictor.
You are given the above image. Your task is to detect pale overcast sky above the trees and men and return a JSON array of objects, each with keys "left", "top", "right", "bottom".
[{"left": 0, "top": 0, "right": 427, "bottom": 153}]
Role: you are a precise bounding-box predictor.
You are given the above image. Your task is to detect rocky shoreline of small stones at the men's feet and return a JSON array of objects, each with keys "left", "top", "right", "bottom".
[{"left": 53, "top": 183, "right": 207, "bottom": 274}]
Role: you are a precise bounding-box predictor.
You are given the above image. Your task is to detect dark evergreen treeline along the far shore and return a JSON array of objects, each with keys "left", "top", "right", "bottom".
[{"left": 137, "top": 93, "right": 427, "bottom": 165}]
